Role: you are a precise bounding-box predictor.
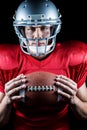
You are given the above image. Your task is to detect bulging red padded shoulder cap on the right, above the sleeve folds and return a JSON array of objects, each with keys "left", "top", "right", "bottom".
[{"left": 60, "top": 40, "right": 87, "bottom": 65}]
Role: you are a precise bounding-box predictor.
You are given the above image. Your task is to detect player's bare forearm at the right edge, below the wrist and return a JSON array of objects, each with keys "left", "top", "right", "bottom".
[{"left": 70, "top": 97, "right": 87, "bottom": 119}]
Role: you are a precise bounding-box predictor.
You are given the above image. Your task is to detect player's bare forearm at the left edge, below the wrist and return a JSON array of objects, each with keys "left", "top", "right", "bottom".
[{"left": 0, "top": 97, "right": 12, "bottom": 127}]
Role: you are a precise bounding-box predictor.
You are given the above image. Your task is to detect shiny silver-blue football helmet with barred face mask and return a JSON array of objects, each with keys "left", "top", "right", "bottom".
[{"left": 13, "top": 0, "right": 62, "bottom": 56}]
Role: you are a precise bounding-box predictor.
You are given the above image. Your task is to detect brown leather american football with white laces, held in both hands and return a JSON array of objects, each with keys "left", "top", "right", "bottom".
[{"left": 21, "top": 71, "right": 61, "bottom": 106}]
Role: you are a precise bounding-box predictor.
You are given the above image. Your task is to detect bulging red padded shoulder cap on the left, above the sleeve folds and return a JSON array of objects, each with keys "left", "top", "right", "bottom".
[{"left": 0, "top": 44, "right": 19, "bottom": 69}]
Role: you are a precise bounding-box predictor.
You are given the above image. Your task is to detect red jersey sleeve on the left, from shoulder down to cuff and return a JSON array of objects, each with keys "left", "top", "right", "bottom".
[{"left": 0, "top": 44, "right": 18, "bottom": 93}]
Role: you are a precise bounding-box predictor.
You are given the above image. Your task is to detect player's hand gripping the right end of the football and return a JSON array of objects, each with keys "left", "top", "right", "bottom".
[{"left": 56, "top": 75, "right": 77, "bottom": 103}]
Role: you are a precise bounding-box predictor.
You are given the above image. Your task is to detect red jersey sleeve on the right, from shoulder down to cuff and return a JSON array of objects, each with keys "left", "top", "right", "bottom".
[{"left": 69, "top": 42, "right": 87, "bottom": 88}]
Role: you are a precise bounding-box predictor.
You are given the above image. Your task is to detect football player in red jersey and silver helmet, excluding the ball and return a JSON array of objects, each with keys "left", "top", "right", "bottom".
[{"left": 0, "top": 0, "right": 87, "bottom": 130}]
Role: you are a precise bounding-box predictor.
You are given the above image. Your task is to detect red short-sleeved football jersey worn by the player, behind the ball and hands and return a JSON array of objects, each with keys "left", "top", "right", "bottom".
[{"left": 0, "top": 41, "right": 87, "bottom": 130}]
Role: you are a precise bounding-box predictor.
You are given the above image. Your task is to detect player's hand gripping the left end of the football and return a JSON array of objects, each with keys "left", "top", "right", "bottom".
[{"left": 5, "top": 74, "right": 26, "bottom": 103}]
